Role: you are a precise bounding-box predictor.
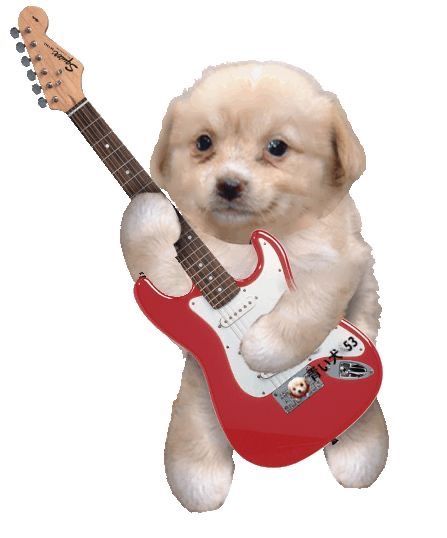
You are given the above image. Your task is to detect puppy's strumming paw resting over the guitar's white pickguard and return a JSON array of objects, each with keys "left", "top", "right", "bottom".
[{"left": 241, "top": 314, "right": 298, "bottom": 372}]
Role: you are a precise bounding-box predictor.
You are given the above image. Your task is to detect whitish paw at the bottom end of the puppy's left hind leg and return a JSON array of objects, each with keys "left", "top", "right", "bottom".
[{"left": 166, "top": 450, "right": 234, "bottom": 512}]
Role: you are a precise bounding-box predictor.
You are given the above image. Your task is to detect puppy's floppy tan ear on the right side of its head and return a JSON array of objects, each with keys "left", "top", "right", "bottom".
[{"left": 328, "top": 92, "right": 366, "bottom": 188}]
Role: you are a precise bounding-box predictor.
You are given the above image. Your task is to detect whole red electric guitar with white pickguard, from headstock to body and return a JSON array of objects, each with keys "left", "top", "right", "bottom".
[{"left": 11, "top": 7, "right": 382, "bottom": 467}]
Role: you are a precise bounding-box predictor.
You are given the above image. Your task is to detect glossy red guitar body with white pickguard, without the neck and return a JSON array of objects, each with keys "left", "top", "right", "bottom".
[{"left": 135, "top": 231, "right": 382, "bottom": 467}]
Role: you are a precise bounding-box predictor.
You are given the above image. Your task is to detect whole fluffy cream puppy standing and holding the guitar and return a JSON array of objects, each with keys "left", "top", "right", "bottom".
[{"left": 122, "top": 62, "right": 388, "bottom": 511}]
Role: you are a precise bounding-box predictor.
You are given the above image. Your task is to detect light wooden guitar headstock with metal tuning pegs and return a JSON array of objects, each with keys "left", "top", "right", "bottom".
[{"left": 11, "top": 6, "right": 84, "bottom": 112}]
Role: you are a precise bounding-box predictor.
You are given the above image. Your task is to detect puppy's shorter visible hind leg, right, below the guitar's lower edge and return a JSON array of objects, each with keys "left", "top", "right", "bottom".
[{"left": 324, "top": 400, "right": 388, "bottom": 488}]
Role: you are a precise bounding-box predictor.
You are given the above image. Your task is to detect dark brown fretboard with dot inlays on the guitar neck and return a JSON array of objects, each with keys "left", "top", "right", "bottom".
[{"left": 67, "top": 99, "right": 239, "bottom": 308}]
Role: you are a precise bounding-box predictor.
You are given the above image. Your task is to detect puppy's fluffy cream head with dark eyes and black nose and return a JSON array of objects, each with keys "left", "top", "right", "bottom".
[{"left": 151, "top": 62, "right": 365, "bottom": 242}]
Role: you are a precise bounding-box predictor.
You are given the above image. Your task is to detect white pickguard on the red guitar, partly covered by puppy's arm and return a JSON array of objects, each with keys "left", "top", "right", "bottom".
[{"left": 189, "top": 241, "right": 363, "bottom": 397}]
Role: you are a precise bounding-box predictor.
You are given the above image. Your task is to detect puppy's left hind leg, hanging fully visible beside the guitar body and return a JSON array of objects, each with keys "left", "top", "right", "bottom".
[{"left": 165, "top": 356, "right": 234, "bottom": 512}]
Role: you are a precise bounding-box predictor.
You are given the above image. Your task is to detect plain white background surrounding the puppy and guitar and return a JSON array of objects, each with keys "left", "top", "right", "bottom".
[{"left": 0, "top": 0, "right": 447, "bottom": 538}]
